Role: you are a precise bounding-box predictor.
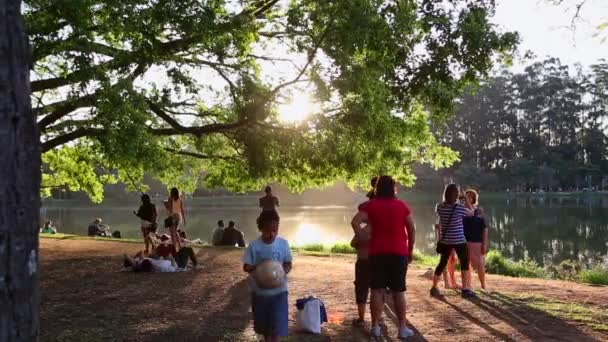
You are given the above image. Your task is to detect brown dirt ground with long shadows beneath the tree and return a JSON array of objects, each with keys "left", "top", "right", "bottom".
[{"left": 40, "top": 239, "right": 608, "bottom": 341}]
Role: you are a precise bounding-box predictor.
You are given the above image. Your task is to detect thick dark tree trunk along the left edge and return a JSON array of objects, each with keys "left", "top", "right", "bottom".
[{"left": 0, "top": 0, "right": 40, "bottom": 342}]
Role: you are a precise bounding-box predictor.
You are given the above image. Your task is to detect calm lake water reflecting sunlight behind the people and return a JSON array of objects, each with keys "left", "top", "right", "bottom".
[{"left": 41, "top": 195, "right": 608, "bottom": 264}]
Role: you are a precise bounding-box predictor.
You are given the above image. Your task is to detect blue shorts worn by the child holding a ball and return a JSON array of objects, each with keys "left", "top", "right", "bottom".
[{"left": 253, "top": 292, "right": 289, "bottom": 336}]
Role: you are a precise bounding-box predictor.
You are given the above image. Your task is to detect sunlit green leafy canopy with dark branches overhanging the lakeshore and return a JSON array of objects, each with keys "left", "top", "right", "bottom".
[{"left": 25, "top": 0, "right": 518, "bottom": 201}]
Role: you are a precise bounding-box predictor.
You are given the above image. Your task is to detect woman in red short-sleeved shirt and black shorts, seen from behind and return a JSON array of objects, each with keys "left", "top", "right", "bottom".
[{"left": 351, "top": 176, "right": 416, "bottom": 338}]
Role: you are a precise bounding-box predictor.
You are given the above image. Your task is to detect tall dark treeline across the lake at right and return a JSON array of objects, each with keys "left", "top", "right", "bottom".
[{"left": 416, "top": 58, "right": 608, "bottom": 191}]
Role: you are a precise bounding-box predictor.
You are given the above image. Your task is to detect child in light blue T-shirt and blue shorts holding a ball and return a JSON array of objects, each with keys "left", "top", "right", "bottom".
[{"left": 243, "top": 210, "right": 292, "bottom": 342}]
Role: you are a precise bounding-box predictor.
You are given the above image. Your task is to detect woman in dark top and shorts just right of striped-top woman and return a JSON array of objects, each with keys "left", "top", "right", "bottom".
[{"left": 463, "top": 189, "right": 488, "bottom": 290}]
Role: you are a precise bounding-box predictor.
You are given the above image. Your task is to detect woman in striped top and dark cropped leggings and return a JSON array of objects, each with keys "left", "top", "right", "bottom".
[{"left": 431, "top": 184, "right": 475, "bottom": 298}]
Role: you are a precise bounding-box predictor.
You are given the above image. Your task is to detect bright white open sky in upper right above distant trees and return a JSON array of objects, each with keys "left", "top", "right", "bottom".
[{"left": 494, "top": 0, "right": 608, "bottom": 68}]
